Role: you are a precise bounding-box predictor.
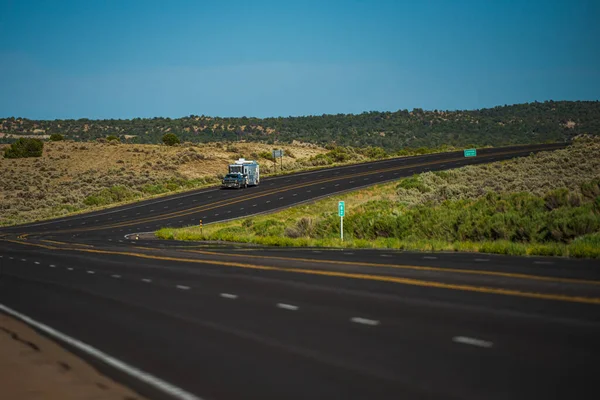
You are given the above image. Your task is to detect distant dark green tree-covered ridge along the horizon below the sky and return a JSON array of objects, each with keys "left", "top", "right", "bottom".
[{"left": 0, "top": 101, "right": 600, "bottom": 150}]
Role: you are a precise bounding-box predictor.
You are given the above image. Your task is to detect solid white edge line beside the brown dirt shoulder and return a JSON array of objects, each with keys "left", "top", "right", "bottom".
[{"left": 0, "top": 304, "right": 202, "bottom": 400}]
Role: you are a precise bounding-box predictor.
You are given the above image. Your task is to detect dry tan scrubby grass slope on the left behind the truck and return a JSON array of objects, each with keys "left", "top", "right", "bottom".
[{"left": 0, "top": 141, "right": 327, "bottom": 226}]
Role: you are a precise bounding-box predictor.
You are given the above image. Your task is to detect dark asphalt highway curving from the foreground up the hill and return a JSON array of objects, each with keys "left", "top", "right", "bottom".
[{"left": 0, "top": 144, "right": 600, "bottom": 399}]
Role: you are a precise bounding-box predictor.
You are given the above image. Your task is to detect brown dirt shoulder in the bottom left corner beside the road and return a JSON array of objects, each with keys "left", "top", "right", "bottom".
[{"left": 0, "top": 314, "right": 142, "bottom": 400}]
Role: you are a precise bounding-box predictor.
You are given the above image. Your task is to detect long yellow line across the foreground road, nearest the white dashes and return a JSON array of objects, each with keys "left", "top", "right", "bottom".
[{"left": 2, "top": 240, "right": 600, "bottom": 305}]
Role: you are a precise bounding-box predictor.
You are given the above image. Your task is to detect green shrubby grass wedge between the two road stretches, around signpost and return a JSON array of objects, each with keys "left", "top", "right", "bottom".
[{"left": 157, "top": 138, "right": 600, "bottom": 257}]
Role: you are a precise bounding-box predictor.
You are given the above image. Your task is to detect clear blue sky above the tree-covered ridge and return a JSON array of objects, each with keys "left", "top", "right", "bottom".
[{"left": 0, "top": 0, "right": 600, "bottom": 119}]
